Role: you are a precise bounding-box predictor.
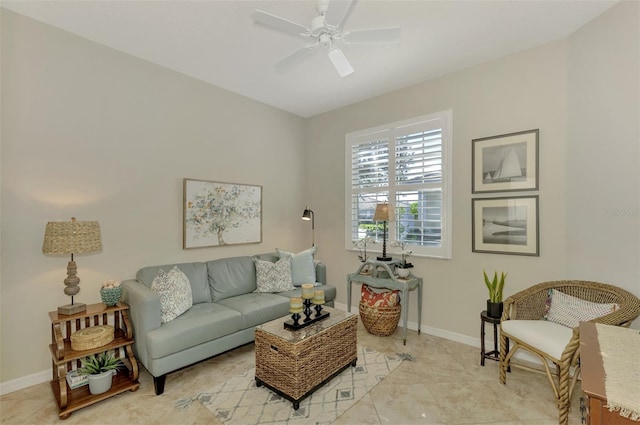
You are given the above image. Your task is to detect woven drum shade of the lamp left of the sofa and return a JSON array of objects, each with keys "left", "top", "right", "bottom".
[{"left": 42, "top": 217, "right": 102, "bottom": 254}]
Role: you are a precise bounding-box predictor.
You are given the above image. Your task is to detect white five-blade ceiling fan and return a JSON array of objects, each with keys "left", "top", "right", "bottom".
[{"left": 251, "top": 0, "right": 401, "bottom": 77}]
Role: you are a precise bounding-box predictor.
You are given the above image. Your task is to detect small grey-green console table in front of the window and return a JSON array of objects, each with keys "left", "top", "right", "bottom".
[{"left": 347, "top": 260, "right": 422, "bottom": 345}]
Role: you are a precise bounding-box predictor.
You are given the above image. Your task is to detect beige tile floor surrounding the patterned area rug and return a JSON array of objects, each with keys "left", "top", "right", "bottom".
[{"left": 0, "top": 318, "right": 582, "bottom": 425}]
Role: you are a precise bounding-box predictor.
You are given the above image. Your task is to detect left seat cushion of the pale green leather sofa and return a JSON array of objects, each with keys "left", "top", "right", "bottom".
[{"left": 146, "top": 303, "right": 242, "bottom": 359}]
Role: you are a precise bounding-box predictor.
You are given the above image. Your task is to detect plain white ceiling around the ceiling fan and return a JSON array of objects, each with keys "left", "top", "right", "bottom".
[{"left": 2, "top": 0, "right": 617, "bottom": 117}]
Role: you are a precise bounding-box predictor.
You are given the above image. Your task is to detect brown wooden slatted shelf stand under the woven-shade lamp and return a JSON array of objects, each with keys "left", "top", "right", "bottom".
[{"left": 49, "top": 303, "right": 140, "bottom": 419}]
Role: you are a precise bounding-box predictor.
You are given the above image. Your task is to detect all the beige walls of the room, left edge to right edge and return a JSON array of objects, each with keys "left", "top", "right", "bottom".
[{"left": 0, "top": 2, "right": 640, "bottom": 390}]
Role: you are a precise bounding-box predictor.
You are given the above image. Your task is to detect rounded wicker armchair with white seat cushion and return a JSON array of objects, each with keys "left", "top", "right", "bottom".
[{"left": 500, "top": 280, "right": 640, "bottom": 425}]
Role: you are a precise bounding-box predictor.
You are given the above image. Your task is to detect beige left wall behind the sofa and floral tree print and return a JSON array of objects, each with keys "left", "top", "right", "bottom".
[{"left": 0, "top": 9, "right": 310, "bottom": 382}]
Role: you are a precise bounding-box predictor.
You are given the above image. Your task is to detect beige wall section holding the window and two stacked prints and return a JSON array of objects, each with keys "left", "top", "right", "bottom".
[{"left": 308, "top": 41, "right": 567, "bottom": 337}]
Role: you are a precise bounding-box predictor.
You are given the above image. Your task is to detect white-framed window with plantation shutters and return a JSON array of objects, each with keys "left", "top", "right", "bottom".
[{"left": 345, "top": 110, "right": 452, "bottom": 258}]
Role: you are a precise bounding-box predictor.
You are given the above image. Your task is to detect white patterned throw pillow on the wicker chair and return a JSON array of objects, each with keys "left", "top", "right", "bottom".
[{"left": 545, "top": 289, "right": 620, "bottom": 328}]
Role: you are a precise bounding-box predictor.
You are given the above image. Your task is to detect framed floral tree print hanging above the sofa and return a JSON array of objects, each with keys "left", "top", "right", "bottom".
[{"left": 183, "top": 179, "right": 262, "bottom": 249}]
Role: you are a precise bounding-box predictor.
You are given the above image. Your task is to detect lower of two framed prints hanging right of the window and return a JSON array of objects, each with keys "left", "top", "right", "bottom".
[{"left": 471, "top": 196, "right": 540, "bottom": 257}]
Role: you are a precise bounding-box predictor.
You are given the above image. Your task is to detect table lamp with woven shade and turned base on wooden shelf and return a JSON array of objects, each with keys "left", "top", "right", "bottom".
[{"left": 42, "top": 217, "right": 102, "bottom": 315}]
